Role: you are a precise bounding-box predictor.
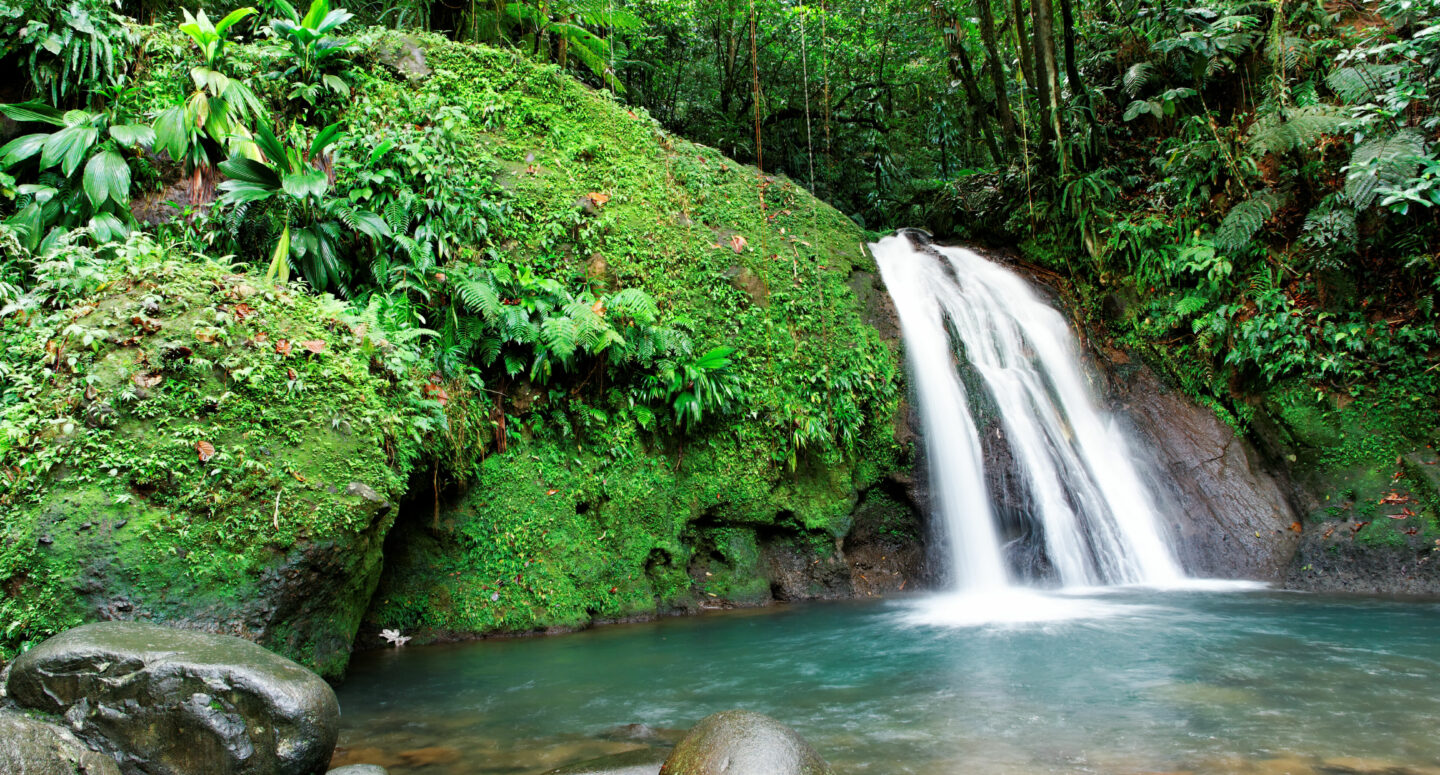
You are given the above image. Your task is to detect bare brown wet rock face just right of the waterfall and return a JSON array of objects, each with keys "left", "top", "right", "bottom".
[{"left": 1112, "top": 367, "right": 1299, "bottom": 581}]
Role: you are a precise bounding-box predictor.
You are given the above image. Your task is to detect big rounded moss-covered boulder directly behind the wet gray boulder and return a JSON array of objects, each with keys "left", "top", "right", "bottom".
[{"left": 0, "top": 239, "right": 419, "bottom": 674}]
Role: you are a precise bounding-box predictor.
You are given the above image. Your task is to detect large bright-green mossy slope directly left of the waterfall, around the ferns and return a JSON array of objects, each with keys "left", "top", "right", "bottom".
[{"left": 354, "top": 39, "right": 901, "bottom": 640}]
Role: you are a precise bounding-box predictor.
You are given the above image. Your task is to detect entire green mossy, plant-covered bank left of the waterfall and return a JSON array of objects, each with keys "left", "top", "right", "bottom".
[{"left": 0, "top": 0, "right": 899, "bottom": 662}]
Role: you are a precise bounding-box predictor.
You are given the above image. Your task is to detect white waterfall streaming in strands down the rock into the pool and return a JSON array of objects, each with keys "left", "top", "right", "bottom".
[{"left": 870, "top": 235, "right": 1182, "bottom": 592}]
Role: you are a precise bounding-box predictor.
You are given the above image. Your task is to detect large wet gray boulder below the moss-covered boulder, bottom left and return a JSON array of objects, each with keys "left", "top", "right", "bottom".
[{"left": 7, "top": 622, "right": 340, "bottom": 775}]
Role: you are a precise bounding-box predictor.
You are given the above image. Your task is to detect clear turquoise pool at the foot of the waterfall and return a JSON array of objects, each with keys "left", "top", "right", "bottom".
[{"left": 337, "top": 589, "right": 1440, "bottom": 775}]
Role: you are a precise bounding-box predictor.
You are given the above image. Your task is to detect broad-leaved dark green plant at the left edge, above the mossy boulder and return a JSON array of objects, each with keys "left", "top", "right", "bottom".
[{"left": 0, "top": 102, "right": 154, "bottom": 254}]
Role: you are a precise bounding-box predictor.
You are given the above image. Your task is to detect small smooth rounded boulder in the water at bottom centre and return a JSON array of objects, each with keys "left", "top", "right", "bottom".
[{"left": 660, "top": 710, "right": 834, "bottom": 775}]
